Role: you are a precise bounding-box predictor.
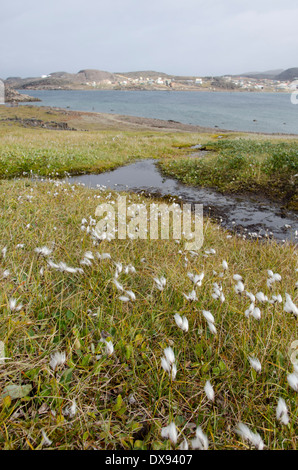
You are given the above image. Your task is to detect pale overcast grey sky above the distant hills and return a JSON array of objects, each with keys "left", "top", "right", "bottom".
[{"left": 0, "top": 0, "right": 298, "bottom": 78}]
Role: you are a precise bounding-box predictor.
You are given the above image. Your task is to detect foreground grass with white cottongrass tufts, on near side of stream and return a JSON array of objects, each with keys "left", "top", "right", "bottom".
[{"left": 0, "top": 179, "right": 298, "bottom": 450}]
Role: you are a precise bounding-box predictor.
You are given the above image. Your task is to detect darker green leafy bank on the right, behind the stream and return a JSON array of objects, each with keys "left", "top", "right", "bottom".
[{"left": 160, "top": 137, "right": 298, "bottom": 209}]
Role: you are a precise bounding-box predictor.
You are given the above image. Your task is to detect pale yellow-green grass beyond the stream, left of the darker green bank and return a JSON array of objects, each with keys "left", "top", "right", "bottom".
[{"left": 0, "top": 106, "right": 203, "bottom": 178}]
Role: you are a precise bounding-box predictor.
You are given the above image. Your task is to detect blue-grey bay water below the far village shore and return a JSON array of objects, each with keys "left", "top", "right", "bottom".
[{"left": 20, "top": 90, "right": 298, "bottom": 134}]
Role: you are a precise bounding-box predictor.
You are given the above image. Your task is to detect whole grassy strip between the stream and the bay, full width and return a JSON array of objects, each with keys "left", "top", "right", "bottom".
[{"left": 0, "top": 106, "right": 298, "bottom": 209}]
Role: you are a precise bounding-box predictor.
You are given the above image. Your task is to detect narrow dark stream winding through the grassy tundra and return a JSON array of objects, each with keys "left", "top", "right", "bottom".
[{"left": 66, "top": 159, "right": 298, "bottom": 243}]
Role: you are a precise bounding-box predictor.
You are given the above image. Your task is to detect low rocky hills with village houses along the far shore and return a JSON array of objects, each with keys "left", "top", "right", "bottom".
[{"left": 3, "top": 68, "right": 298, "bottom": 98}]
